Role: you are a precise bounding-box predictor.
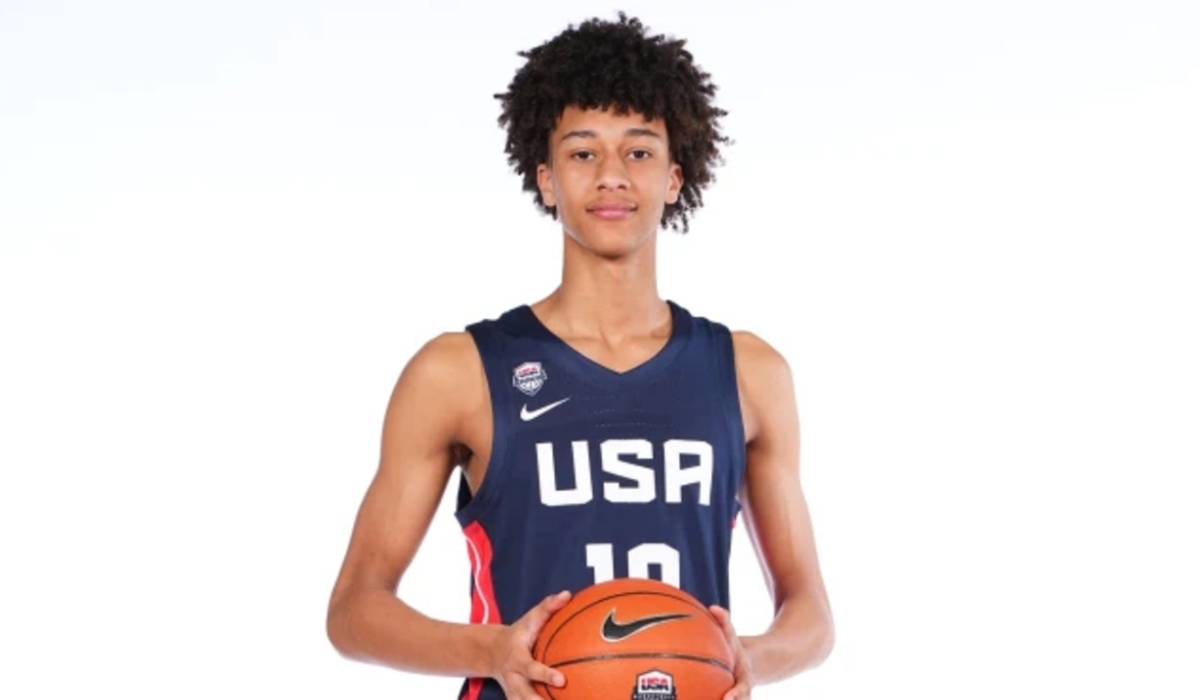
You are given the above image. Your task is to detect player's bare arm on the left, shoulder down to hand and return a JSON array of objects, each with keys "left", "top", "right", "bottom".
[{"left": 326, "top": 333, "right": 565, "bottom": 698}]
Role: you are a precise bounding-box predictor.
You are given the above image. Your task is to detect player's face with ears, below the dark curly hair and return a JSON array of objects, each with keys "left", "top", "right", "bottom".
[{"left": 538, "top": 107, "right": 683, "bottom": 257}]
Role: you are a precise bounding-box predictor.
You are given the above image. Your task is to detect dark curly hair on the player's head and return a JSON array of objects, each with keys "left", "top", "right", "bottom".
[{"left": 496, "top": 12, "right": 730, "bottom": 233}]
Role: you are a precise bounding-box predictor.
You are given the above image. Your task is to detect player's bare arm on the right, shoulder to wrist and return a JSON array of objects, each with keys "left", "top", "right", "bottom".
[{"left": 733, "top": 333, "right": 834, "bottom": 683}]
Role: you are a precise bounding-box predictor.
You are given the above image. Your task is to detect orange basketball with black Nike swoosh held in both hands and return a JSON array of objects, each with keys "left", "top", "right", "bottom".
[{"left": 533, "top": 579, "right": 733, "bottom": 700}]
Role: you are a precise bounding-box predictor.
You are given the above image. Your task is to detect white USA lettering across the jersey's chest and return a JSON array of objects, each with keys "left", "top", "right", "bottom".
[{"left": 536, "top": 439, "right": 713, "bottom": 505}]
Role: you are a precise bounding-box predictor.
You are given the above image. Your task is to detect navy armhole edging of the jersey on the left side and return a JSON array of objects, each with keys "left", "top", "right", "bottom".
[{"left": 455, "top": 323, "right": 512, "bottom": 527}]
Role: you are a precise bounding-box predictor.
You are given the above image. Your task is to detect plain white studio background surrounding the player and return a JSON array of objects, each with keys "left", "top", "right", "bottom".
[{"left": 0, "top": 0, "right": 1200, "bottom": 700}]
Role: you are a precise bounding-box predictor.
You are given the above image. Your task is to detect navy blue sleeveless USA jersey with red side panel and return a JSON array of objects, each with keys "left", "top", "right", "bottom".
[{"left": 456, "top": 303, "right": 745, "bottom": 700}]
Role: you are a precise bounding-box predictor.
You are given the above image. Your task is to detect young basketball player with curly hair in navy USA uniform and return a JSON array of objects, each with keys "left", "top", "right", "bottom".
[{"left": 329, "top": 14, "right": 833, "bottom": 700}]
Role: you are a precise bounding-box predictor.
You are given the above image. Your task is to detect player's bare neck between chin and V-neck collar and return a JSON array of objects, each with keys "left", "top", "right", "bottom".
[{"left": 534, "top": 234, "right": 670, "bottom": 337}]
